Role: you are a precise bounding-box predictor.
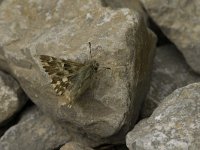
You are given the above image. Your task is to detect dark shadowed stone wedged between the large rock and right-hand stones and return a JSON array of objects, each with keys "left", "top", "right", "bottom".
[{"left": 141, "top": 45, "right": 200, "bottom": 118}]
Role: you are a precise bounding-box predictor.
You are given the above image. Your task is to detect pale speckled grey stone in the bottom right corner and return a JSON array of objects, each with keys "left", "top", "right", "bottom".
[{"left": 126, "top": 83, "right": 200, "bottom": 150}]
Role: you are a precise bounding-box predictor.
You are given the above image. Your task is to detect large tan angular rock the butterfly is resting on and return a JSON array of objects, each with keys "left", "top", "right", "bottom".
[{"left": 0, "top": 0, "right": 156, "bottom": 141}]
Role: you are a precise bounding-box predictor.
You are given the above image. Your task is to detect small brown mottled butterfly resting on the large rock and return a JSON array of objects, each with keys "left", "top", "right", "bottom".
[{"left": 39, "top": 42, "right": 99, "bottom": 107}]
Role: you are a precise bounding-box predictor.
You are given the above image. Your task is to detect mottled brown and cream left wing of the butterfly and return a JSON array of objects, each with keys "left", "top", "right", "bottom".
[{"left": 40, "top": 55, "right": 84, "bottom": 95}]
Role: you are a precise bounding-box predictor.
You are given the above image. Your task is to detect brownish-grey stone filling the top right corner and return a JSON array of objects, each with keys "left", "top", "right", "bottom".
[{"left": 141, "top": 0, "right": 200, "bottom": 73}]
